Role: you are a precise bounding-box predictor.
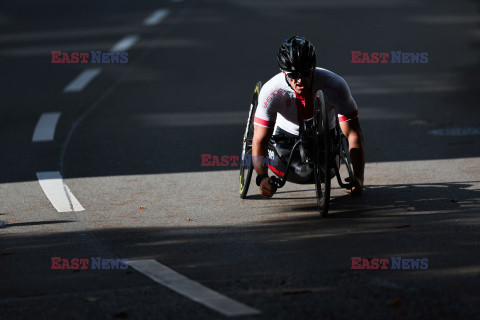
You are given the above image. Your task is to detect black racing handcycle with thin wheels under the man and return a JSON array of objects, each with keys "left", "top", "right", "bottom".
[{"left": 240, "top": 82, "right": 354, "bottom": 217}]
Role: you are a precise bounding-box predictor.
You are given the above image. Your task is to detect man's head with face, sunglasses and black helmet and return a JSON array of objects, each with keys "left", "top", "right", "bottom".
[{"left": 277, "top": 36, "right": 316, "bottom": 94}]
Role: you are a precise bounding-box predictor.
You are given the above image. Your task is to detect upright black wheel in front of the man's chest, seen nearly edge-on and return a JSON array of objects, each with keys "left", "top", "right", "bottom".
[{"left": 313, "top": 90, "right": 332, "bottom": 217}]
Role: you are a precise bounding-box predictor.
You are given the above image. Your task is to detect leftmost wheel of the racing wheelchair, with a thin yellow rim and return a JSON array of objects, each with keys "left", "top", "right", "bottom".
[{"left": 240, "top": 81, "right": 262, "bottom": 199}]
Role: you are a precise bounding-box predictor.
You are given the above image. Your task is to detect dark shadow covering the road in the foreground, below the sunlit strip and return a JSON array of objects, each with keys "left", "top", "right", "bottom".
[{"left": 0, "top": 191, "right": 480, "bottom": 319}]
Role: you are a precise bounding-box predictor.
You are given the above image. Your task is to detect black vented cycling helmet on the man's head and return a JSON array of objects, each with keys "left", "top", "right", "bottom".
[{"left": 277, "top": 36, "right": 316, "bottom": 72}]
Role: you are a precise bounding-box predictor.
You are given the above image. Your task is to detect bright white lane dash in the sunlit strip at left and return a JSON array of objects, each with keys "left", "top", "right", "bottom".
[{"left": 37, "top": 171, "right": 85, "bottom": 212}]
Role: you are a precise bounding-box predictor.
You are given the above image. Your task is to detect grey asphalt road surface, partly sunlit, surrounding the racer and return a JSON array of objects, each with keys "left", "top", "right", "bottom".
[{"left": 0, "top": 0, "right": 480, "bottom": 319}]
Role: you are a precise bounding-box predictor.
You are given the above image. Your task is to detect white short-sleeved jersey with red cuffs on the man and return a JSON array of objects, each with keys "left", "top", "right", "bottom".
[{"left": 254, "top": 68, "right": 358, "bottom": 135}]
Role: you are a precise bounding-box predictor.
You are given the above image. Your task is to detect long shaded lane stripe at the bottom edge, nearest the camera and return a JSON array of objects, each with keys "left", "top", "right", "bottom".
[{"left": 128, "top": 259, "right": 262, "bottom": 317}]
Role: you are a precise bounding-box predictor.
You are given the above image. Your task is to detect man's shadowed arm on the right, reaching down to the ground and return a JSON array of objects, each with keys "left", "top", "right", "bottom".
[{"left": 340, "top": 117, "right": 365, "bottom": 196}]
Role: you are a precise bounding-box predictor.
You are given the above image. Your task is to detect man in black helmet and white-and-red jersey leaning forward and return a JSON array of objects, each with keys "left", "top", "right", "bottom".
[{"left": 252, "top": 36, "right": 365, "bottom": 197}]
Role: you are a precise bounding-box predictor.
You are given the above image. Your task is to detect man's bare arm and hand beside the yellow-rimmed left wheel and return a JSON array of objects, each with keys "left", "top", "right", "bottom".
[{"left": 252, "top": 124, "right": 277, "bottom": 198}]
